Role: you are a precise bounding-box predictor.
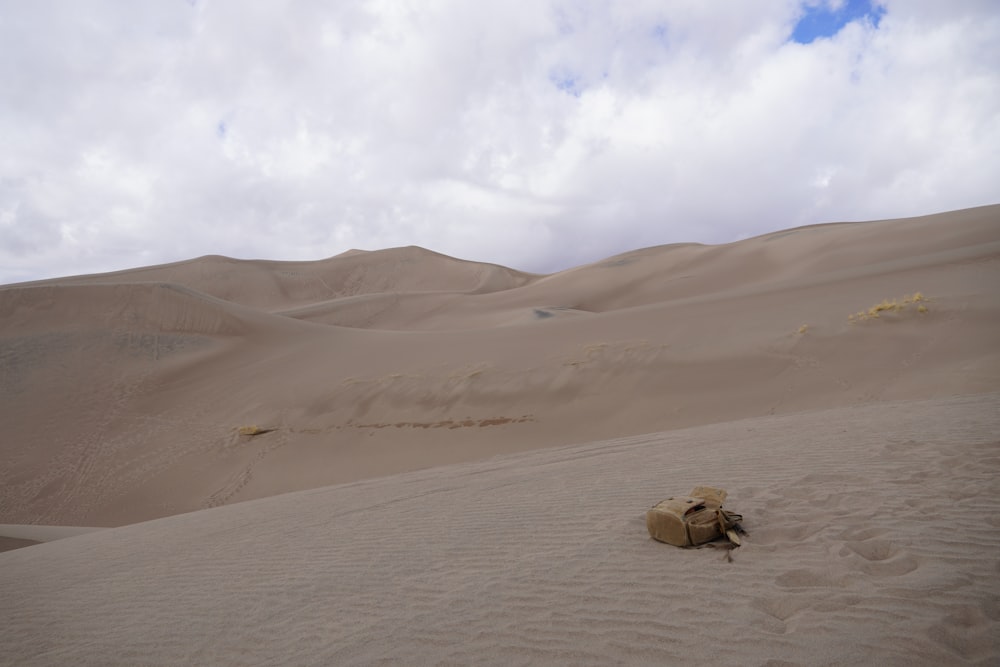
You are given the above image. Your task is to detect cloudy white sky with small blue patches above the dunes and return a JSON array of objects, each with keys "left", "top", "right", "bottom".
[{"left": 0, "top": 0, "right": 1000, "bottom": 283}]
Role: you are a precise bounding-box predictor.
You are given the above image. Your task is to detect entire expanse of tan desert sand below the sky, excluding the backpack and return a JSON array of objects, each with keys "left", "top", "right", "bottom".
[{"left": 0, "top": 206, "right": 1000, "bottom": 665}]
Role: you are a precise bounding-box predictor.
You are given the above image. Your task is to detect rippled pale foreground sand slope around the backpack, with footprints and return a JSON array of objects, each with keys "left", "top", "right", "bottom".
[{"left": 0, "top": 394, "right": 1000, "bottom": 666}]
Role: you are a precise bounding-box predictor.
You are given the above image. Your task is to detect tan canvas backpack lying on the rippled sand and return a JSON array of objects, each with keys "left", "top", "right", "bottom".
[{"left": 646, "top": 486, "right": 743, "bottom": 547}]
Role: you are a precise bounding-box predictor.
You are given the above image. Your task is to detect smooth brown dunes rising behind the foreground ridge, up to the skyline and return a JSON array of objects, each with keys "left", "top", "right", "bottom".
[{"left": 0, "top": 206, "right": 1000, "bottom": 526}]
